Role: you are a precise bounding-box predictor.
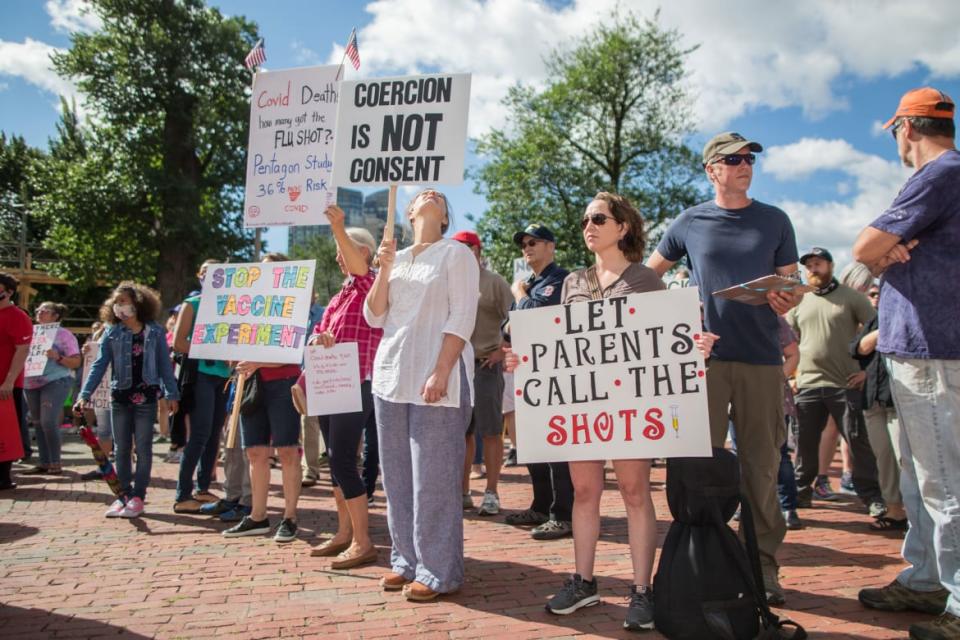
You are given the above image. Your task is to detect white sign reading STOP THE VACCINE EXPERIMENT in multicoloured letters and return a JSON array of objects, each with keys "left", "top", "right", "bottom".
[{"left": 190, "top": 260, "right": 317, "bottom": 364}]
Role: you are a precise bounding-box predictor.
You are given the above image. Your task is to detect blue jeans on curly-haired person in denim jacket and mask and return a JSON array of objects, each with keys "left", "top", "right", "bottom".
[{"left": 112, "top": 402, "right": 157, "bottom": 500}]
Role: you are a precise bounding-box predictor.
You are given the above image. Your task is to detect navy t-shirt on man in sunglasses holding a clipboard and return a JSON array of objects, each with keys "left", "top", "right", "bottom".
[{"left": 657, "top": 200, "right": 798, "bottom": 365}]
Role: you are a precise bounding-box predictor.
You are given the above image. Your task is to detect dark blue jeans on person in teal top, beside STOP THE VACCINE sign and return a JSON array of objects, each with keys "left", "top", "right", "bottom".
[{"left": 175, "top": 373, "right": 227, "bottom": 502}]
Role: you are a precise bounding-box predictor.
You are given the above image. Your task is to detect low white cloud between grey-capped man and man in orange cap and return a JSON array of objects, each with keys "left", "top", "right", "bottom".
[{"left": 762, "top": 138, "right": 911, "bottom": 268}]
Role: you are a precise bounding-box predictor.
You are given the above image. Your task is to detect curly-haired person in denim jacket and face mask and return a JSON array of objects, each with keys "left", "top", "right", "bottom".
[{"left": 74, "top": 282, "right": 180, "bottom": 518}]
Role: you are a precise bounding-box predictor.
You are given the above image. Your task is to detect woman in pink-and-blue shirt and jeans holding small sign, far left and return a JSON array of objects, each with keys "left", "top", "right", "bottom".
[{"left": 23, "top": 302, "right": 81, "bottom": 475}]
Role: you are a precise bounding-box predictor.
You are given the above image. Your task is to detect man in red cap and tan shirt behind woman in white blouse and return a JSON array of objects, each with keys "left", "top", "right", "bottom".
[{"left": 453, "top": 231, "right": 513, "bottom": 516}]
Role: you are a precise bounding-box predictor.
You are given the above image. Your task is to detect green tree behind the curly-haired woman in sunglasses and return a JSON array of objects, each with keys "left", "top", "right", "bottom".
[{"left": 474, "top": 15, "right": 706, "bottom": 273}]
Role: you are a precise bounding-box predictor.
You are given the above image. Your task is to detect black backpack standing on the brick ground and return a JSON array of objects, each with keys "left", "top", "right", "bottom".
[{"left": 653, "top": 449, "right": 807, "bottom": 640}]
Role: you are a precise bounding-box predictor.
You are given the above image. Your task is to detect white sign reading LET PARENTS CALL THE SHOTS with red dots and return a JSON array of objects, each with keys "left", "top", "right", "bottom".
[{"left": 510, "top": 288, "right": 711, "bottom": 463}]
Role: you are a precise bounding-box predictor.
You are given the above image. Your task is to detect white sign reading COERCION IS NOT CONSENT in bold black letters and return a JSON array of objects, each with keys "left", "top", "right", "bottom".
[{"left": 333, "top": 74, "right": 470, "bottom": 187}]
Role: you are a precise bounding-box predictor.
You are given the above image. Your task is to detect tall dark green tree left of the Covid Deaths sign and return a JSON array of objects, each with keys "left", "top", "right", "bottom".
[{"left": 37, "top": 0, "right": 257, "bottom": 303}]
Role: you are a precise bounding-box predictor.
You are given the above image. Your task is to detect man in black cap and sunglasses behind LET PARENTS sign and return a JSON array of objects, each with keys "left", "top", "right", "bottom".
[{"left": 504, "top": 222, "right": 573, "bottom": 540}]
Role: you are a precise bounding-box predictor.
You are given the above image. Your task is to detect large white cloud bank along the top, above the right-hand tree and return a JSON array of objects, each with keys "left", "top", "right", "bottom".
[{"left": 346, "top": 0, "right": 960, "bottom": 135}]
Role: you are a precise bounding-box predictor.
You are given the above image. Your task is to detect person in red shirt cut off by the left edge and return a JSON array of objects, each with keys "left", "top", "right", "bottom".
[{"left": 0, "top": 272, "right": 33, "bottom": 490}]
